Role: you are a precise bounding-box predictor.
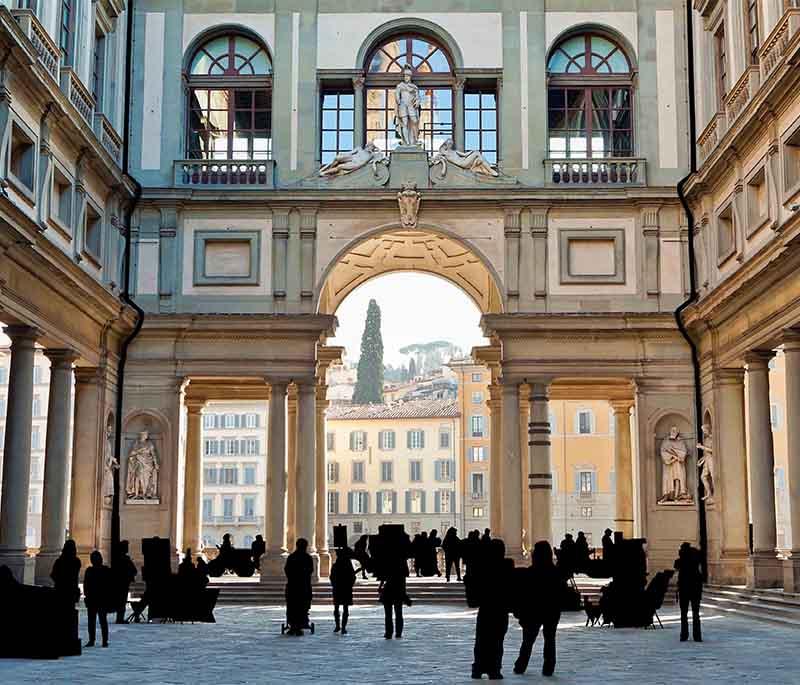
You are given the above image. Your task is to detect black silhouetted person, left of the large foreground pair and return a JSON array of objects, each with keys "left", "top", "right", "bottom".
[{"left": 470, "top": 538, "right": 514, "bottom": 680}]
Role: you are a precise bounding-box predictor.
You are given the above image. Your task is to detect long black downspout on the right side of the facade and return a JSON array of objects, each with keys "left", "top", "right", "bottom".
[{"left": 675, "top": 0, "right": 708, "bottom": 582}]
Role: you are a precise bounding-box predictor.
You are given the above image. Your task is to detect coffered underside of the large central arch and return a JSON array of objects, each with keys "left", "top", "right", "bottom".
[{"left": 316, "top": 226, "right": 503, "bottom": 314}]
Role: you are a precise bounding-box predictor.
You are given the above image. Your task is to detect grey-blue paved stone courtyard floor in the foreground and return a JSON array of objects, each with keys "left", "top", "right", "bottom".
[{"left": 0, "top": 606, "right": 800, "bottom": 685}]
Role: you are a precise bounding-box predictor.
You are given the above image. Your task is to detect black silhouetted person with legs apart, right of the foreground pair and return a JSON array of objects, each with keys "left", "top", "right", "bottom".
[{"left": 514, "top": 540, "right": 566, "bottom": 676}]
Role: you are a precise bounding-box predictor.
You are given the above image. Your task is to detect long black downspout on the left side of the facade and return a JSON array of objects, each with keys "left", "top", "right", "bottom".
[{"left": 111, "top": 0, "right": 144, "bottom": 565}]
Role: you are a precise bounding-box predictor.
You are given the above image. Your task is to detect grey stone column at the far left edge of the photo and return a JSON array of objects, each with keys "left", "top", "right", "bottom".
[{"left": 0, "top": 326, "right": 39, "bottom": 582}]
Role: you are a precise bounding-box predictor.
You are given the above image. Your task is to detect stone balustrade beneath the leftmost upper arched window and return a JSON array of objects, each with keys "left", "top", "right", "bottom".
[{"left": 174, "top": 159, "right": 275, "bottom": 189}]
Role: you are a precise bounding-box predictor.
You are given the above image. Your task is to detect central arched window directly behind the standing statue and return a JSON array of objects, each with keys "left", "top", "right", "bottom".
[{"left": 365, "top": 34, "right": 454, "bottom": 152}]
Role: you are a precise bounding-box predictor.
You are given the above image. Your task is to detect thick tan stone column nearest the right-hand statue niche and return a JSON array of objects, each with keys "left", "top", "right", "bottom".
[{"left": 713, "top": 369, "right": 750, "bottom": 584}]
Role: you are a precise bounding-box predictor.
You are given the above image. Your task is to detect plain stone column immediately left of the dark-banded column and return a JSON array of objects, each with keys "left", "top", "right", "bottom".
[{"left": 500, "top": 379, "right": 522, "bottom": 559}]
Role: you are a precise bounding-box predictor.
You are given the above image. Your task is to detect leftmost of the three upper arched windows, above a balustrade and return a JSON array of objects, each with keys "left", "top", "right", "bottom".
[{"left": 186, "top": 34, "right": 272, "bottom": 160}]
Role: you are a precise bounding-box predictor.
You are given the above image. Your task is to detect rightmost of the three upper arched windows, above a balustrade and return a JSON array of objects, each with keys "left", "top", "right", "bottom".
[{"left": 547, "top": 33, "right": 634, "bottom": 159}]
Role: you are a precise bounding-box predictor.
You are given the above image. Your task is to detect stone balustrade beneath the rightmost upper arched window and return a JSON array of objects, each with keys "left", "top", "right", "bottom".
[{"left": 544, "top": 157, "right": 647, "bottom": 188}]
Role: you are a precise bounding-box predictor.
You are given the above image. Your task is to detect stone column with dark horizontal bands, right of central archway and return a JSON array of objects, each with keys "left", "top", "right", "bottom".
[{"left": 528, "top": 381, "right": 553, "bottom": 549}]
